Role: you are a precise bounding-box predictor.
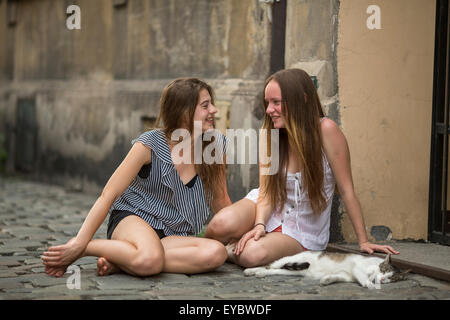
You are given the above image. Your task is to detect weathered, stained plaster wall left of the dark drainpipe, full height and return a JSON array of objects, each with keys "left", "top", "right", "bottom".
[{"left": 0, "top": 0, "right": 270, "bottom": 200}]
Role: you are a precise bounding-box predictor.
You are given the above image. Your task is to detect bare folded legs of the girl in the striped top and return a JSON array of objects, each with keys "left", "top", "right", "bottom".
[{"left": 47, "top": 216, "right": 227, "bottom": 276}]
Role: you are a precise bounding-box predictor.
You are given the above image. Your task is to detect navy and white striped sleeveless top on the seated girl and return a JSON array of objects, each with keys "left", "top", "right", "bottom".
[{"left": 110, "top": 130, "right": 214, "bottom": 236}]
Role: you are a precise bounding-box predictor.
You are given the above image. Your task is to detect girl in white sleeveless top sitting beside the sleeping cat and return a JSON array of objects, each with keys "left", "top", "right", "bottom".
[{"left": 205, "top": 69, "right": 398, "bottom": 268}]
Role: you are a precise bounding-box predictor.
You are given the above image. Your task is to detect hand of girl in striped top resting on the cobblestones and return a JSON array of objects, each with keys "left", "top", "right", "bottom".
[{"left": 41, "top": 238, "right": 85, "bottom": 276}]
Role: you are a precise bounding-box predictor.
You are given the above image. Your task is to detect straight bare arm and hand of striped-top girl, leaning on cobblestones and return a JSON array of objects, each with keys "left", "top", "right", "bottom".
[{"left": 43, "top": 143, "right": 151, "bottom": 267}]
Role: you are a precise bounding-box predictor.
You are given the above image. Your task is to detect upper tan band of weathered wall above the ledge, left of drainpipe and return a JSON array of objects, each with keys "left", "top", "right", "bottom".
[{"left": 6, "top": 0, "right": 270, "bottom": 80}]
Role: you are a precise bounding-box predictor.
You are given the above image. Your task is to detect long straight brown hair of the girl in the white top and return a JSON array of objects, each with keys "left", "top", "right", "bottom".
[{"left": 260, "top": 69, "right": 326, "bottom": 214}]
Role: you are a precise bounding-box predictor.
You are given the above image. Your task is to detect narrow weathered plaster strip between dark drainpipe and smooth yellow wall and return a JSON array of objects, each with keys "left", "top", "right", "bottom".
[{"left": 285, "top": 0, "right": 340, "bottom": 123}]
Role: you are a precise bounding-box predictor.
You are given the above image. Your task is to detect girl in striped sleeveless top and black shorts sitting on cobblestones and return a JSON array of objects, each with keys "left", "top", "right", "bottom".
[{"left": 42, "top": 78, "right": 231, "bottom": 277}]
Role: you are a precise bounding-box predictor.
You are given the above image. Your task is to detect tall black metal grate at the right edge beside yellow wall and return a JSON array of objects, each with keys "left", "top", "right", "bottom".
[{"left": 428, "top": 0, "right": 450, "bottom": 245}]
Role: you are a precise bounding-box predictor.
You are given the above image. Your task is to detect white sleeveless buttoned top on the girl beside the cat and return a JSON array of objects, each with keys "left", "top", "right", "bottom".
[{"left": 245, "top": 120, "right": 336, "bottom": 250}]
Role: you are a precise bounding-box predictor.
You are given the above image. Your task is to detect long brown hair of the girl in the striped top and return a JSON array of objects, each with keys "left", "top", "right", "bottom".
[{"left": 155, "top": 78, "right": 225, "bottom": 208}]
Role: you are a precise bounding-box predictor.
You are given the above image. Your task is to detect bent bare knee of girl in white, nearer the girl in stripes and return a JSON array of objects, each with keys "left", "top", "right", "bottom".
[{"left": 205, "top": 199, "right": 256, "bottom": 244}]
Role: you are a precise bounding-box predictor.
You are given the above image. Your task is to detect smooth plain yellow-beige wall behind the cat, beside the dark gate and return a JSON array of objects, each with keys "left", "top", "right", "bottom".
[{"left": 337, "top": 0, "right": 436, "bottom": 241}]
